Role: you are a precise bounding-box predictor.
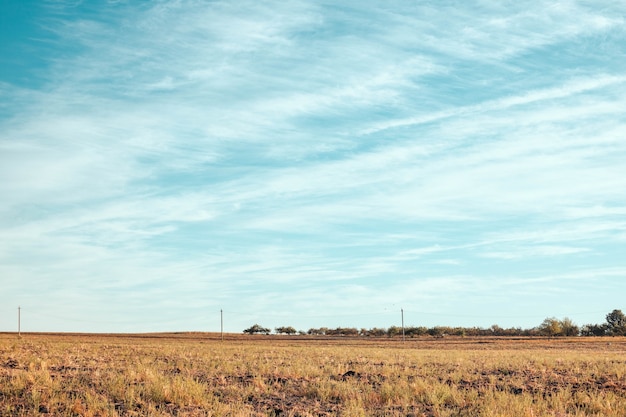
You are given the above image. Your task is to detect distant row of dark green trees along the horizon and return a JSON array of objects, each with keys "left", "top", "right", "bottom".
[{"left": 243, "top": 310, "right": 626, "bottom": 337}]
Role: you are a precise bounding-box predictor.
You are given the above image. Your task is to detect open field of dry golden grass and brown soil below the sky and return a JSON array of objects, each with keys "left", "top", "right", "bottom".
[{"left": 0, "top": 333, "right": 626, "bottom": 417}]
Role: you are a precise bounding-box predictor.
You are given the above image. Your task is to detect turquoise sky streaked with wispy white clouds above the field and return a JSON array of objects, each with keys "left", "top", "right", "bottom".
[{"left": 0, "top": 0, "right": 626, "bottom": 332}]
